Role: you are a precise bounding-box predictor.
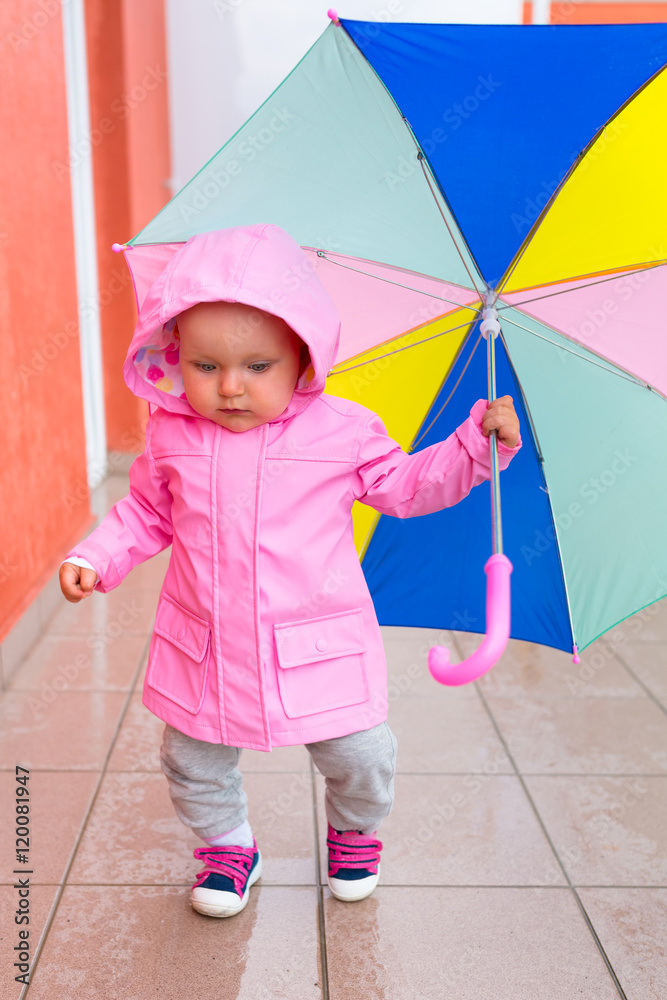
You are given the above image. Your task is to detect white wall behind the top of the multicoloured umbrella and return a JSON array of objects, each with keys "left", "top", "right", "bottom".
[{"left": 166, "top": 0, "right": 523, "bottom": 191}]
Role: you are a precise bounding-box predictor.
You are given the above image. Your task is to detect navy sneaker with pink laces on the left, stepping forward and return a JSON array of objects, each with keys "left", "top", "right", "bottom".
[{"left": 190, "top": 840, "right": 262, "bottom": 917}]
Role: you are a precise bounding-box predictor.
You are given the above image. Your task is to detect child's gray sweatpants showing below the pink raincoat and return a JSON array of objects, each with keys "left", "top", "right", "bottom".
[{"left": 160, "top": 722, "right": 396, "bottom": 837}]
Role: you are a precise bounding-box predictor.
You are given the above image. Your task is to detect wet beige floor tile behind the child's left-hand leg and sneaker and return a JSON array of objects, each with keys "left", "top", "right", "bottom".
[{"left": 69, "top": 772, "right": 315, "bottom": 885}]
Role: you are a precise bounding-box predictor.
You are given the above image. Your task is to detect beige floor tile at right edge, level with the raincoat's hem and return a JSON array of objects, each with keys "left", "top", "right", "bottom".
[{"left": 487, "top": 695, "right": 667, "bottom": 774}]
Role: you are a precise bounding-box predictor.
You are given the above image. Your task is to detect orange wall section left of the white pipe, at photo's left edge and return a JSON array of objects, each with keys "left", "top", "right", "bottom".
[{"left": 0, "top": 0, "right": 90, "bottom": 638}]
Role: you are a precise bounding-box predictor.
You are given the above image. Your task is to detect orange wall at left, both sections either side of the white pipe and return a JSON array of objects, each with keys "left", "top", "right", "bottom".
[{"left": 0, "top": 0, "right": 169, "bottom": 641}]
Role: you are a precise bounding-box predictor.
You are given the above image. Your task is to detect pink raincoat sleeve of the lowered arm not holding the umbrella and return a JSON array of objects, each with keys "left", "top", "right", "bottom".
[{"left": 65, "top": 422, "right": 172, "bottom": 593}]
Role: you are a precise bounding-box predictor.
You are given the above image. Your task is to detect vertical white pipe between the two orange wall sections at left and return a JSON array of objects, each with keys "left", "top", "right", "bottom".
[{"left": 61, "top": 0, "right": 107, "bottom": 489}]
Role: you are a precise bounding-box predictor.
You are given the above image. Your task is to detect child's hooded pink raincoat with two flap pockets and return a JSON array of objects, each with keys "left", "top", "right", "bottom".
[{"left": 70, "top": 225, "right": 521, "bottom": 750}]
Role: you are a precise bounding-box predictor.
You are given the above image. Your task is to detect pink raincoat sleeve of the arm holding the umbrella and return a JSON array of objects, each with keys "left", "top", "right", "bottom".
[{"left": 354, "top": 399, "right": 521, "bottom": 517}]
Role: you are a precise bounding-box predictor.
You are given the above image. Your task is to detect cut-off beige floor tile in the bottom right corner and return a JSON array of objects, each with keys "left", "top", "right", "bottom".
[{"left": 579, "top": 889, "right": 667, "bottom": 1000}]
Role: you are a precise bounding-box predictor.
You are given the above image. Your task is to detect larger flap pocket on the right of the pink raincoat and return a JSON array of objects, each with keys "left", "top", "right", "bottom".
[{"left": 273, "top": 609, "right": 368, "bottom": 719}]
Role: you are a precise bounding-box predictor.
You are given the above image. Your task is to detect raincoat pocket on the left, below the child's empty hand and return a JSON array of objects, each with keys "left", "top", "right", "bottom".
[{"left": 146, "top": 594, "right": 211, "bottom": 715}]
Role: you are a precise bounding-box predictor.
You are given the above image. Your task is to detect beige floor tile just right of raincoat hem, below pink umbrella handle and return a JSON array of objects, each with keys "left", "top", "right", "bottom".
[{"left": 389, "top": 688, "right": 514, "bottom": 774}]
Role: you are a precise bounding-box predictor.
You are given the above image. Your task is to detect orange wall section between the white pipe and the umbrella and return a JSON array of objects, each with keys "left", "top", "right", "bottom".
[{"left": 85, "top": 0, "right": 169, "bottom": 451}]
